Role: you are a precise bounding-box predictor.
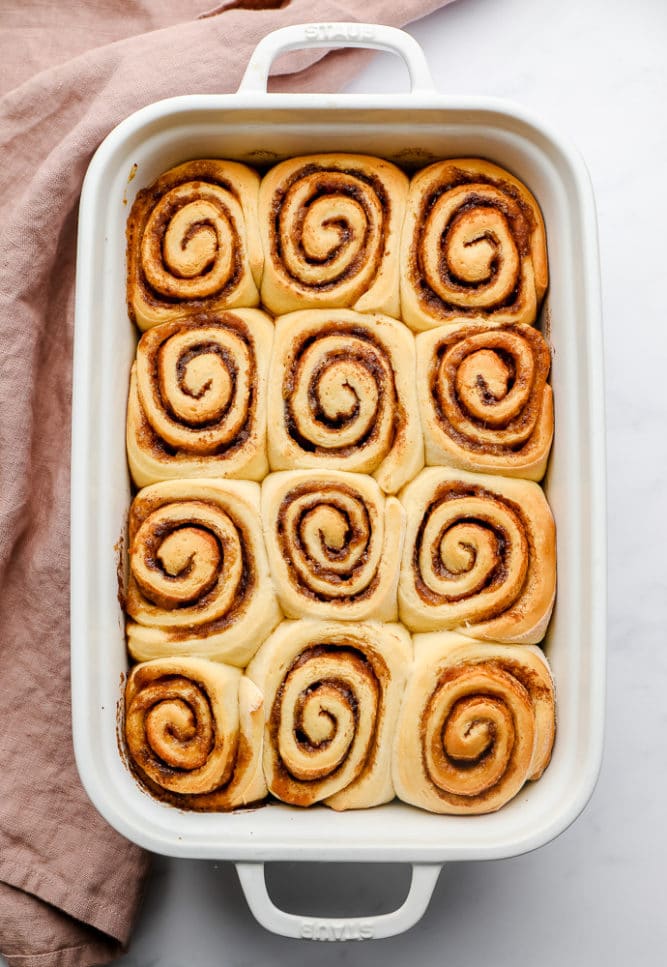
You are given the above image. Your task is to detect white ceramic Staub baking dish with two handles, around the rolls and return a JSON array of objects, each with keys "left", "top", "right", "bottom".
[{"left": 71, "top": 24, "right": 606, "bottom": 940}]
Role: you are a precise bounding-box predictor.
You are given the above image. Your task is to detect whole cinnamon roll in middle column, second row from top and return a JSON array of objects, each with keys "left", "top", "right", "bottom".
[{"left": 268, "top": 309, "right": 424, "bottom": 494}]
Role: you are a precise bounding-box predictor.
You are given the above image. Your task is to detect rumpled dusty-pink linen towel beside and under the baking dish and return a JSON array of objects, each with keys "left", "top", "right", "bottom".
[{"left": 0, "top": 0, "right": 448, "bottom": 967}]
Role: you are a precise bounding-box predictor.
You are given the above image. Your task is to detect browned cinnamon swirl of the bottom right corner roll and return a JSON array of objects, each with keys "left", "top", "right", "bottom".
[{"left": 421, "top": 663, "right": 535, "bottom": 799}]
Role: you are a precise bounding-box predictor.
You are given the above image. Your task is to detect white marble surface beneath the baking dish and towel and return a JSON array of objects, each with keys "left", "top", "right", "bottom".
[{"left": 32, "top": 0, "right": 667, "bottom": 967}]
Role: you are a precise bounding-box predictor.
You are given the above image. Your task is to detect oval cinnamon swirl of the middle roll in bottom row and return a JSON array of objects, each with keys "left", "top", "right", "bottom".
[{"left": 271, "top": 645, "right": 381, "bottom": 783}]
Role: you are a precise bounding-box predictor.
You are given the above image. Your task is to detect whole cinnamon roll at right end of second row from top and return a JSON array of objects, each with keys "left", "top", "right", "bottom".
[{"left": 416, "top": 324, "right": 554, "bottom": 480}]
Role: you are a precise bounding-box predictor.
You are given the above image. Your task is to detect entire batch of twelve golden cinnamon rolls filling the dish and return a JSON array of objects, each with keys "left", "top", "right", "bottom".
[{"left": 118, "top": 154, "right": 556, "bottom": 814}]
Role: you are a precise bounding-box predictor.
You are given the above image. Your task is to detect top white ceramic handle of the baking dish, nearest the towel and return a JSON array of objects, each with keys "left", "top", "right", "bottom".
[{"left": 239, "top": 23, "right": 435, "bottom": 94}]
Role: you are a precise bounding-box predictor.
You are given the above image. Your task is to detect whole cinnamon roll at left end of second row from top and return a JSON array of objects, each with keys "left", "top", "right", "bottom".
[{"left": 127, "top": 309, "right": 273, "bottom": 487}]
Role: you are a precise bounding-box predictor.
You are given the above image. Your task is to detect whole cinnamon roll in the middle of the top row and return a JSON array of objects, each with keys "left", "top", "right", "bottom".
[{"left": 259, "top": 154, "right": 408, "bottom": 316}]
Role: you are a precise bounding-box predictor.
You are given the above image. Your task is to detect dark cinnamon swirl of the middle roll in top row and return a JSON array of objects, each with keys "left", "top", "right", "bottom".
[{"left": 274, "top": 168, "right": 386, "bottom": 290}]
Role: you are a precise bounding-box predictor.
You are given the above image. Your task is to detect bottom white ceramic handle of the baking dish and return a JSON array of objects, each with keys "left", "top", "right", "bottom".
[{"left": 236, "top": 863, "right": 442, "bottom": 941}]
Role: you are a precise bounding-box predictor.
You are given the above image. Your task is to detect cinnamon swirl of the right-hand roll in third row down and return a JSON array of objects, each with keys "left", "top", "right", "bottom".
[{"left": 414, "top": 488, "right": 529, "bottom": 621}]
